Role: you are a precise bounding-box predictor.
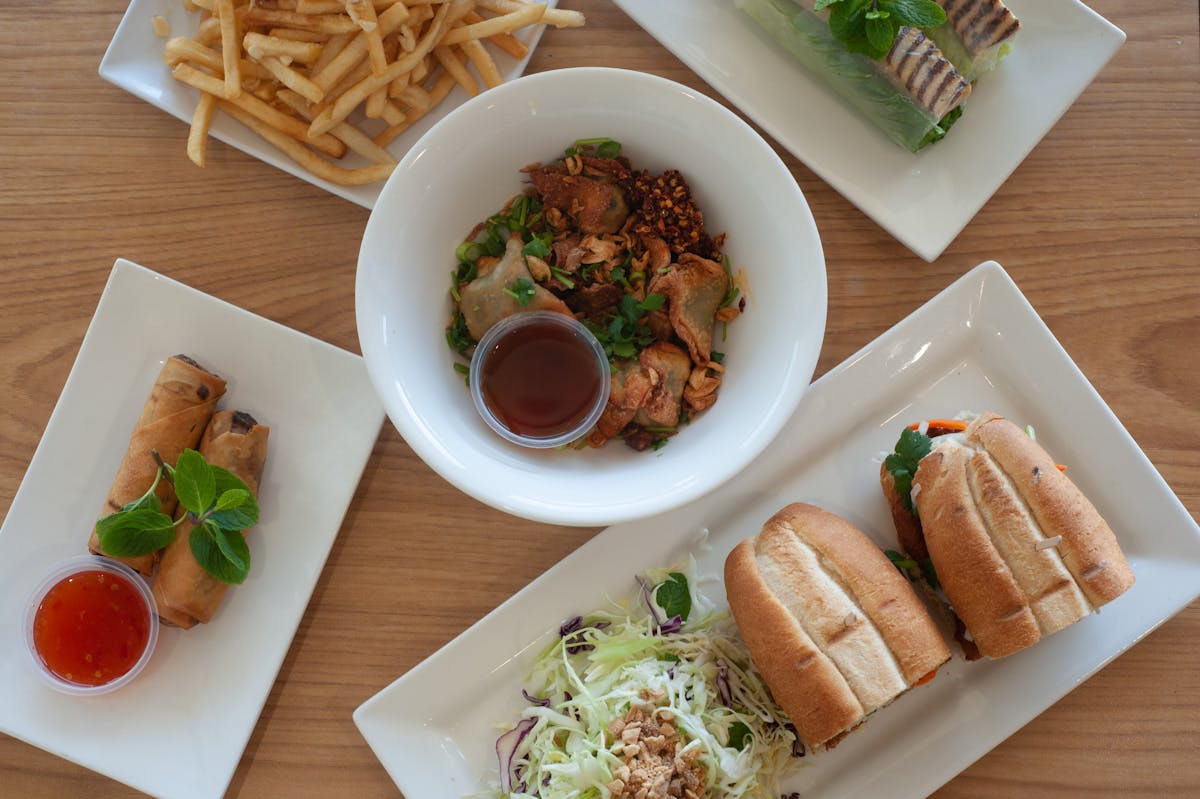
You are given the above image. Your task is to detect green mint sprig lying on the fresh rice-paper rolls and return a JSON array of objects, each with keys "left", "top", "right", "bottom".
[{"left": 812, "top": 0, "right": 946, "bottom": 61}]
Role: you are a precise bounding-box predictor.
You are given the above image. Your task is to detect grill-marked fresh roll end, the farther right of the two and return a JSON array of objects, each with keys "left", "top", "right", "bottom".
[{"left": 929, "top": 0, "right": 1021, "bottom": 83}]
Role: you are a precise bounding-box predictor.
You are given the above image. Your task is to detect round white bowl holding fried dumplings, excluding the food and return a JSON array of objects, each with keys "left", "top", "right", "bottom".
[{"left": 355, "top": 68, "right": 826, "bottom": 525}]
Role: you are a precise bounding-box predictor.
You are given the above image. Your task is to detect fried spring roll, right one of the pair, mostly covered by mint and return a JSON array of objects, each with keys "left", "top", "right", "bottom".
[{"left": 151, "top": 410, "right": 271, "bottom": 627}]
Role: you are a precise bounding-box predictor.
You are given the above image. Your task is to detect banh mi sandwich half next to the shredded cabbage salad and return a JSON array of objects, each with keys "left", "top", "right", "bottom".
[{"left": 725, "top": 503, "right": 950, "bottom": 751}]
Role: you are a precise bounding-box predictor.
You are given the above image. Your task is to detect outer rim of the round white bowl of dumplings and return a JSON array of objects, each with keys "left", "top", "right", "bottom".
[{"left": 355, "top": 67, "right": 828, "bottom": 527}]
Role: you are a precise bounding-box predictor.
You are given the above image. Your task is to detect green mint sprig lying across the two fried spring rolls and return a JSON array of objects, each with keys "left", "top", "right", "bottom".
[{"left": 96, "top": 450, "right": 258, "bottom": 583}]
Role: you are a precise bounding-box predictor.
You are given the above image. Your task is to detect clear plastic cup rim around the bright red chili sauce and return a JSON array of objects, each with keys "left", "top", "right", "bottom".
[{"left": 22, "top": 554, "right": 161, "bottom": 696}]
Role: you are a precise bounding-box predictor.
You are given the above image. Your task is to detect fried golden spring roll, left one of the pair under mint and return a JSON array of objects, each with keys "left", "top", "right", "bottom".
[{"left": 88, "top": 355, "right": 226, "bottom": 577}]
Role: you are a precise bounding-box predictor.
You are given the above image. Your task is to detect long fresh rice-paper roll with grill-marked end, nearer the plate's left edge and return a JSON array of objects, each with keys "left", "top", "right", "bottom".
[{"left": 738, "top": 0, "right": 971, "bottom": 152}]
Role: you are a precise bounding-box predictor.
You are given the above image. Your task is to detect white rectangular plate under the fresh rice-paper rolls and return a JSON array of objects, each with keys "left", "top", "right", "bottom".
[{"left": 616, "top": 0, "right": 1124, "bottom": 260}]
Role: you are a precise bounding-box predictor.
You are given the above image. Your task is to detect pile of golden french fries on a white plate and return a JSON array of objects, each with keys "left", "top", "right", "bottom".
[{"left": 163, "top": 0, "right": 584, "bottom": 186}]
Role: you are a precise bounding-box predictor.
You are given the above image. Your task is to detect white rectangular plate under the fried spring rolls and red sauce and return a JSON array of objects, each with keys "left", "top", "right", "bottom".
[{"left": 0, "top": 260, "right": 383, "bottom": 799}]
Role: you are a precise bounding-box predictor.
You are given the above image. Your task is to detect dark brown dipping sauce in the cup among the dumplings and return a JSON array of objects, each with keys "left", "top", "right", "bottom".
[{"left": 480, "top": 320, "right": 608, "bottom": 438}]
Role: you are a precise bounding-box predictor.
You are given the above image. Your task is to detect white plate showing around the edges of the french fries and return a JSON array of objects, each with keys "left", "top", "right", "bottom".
[{"left": 100, "top": 0, "right": 558, "bottom": 208}]
